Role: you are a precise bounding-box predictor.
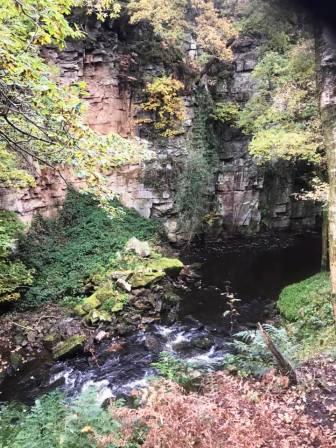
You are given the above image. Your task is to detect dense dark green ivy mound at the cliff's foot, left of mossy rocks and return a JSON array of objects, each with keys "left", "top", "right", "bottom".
[{"left": 20, "top": 191, "right": 157, "bottom": 305}]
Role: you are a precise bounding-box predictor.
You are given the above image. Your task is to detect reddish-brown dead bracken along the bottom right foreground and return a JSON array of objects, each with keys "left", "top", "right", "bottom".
[{"left": 107, "top": 372, "right": 335, "bottom": 448}]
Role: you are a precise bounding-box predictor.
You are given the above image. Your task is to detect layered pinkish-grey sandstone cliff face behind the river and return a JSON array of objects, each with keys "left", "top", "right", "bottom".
[{"left": 0, "top": 0, "right": 320, "bottom": 241}]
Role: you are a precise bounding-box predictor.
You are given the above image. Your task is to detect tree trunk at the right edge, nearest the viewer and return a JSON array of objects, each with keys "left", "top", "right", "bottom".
[{"left": 316, "top": 25, "right": 336, "bottom": 320}]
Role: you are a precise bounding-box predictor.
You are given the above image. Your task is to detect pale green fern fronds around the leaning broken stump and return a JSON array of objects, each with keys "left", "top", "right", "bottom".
[{"left": 223, "top": 325, "right": 299, "bottom": 376}]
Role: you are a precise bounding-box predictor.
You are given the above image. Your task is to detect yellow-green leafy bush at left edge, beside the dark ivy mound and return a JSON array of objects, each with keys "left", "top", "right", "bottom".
[{"left": 0, "top": 212, "right": 32, "bottom": 304}]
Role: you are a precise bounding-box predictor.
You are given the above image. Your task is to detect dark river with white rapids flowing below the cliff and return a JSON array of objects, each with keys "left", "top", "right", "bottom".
[{"left": 0, "top": 235, "right": 321, "bottom": 402}]
